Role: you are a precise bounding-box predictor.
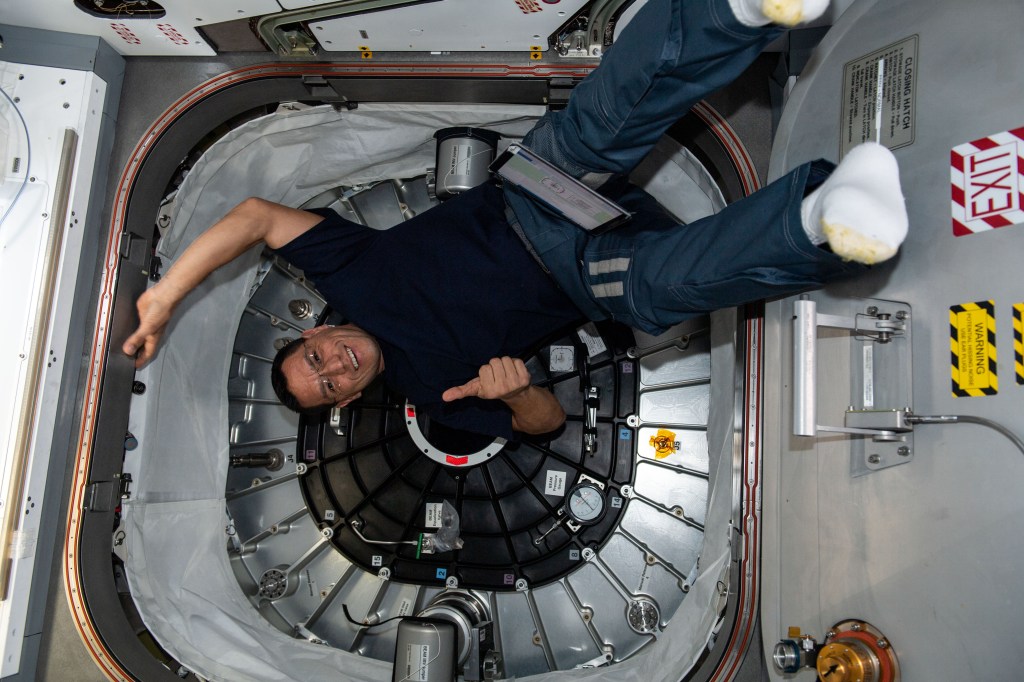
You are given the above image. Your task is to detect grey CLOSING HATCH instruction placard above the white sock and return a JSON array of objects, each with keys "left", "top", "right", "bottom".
[{"left": 840, "top": 36, "right": 918, "bottom": 159}]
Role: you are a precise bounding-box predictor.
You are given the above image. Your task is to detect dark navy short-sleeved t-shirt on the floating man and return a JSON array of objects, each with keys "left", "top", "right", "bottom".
[{"left": 278, "top": 183, "right": 583, "bottom": 438}]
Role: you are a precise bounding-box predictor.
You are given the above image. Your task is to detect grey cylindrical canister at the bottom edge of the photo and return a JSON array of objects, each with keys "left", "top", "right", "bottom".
[{"left": 391, "top": 617, "right": 457, "bottom": 682}]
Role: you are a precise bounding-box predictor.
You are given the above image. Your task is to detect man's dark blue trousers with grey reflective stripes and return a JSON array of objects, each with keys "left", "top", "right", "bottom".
[{"left": 505, "top": 0, "right": 862, "bottom": 334}]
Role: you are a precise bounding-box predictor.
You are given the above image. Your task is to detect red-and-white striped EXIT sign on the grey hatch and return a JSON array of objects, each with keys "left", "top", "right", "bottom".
[{"left": 949, "top": 127, "right": 1024, "bottom": 237}]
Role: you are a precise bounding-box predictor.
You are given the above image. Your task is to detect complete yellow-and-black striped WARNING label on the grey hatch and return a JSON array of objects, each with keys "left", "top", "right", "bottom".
[{"left": 949, "top": 301, "right": 999, "bottom": 397}]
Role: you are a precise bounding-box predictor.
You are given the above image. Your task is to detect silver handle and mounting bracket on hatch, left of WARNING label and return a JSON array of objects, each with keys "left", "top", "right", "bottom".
[{"left": 793, "top": 295, "right": 913, "bottom": 476}]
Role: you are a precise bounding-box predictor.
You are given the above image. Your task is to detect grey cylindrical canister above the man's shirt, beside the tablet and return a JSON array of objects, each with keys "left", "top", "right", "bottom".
[{"left": 434, "top": 126, "right": 501, "bottom": 202}]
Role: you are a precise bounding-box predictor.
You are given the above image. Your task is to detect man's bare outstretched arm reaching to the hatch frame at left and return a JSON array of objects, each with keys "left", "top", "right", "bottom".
[{"left": 122, "top": 199, "right": 323, "bottom": 367}]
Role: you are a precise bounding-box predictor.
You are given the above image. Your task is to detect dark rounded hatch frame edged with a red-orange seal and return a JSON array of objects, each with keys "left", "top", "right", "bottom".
[{"left": 63, "top": 63, "right": 761, "bottom": 680}]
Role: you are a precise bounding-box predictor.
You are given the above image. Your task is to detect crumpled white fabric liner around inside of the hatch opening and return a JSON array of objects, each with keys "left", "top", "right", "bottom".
[{"left": 124, "top": 100, "right": 733, "bottom": 682}]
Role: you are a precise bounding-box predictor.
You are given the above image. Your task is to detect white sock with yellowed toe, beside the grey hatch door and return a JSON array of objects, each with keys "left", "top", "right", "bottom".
[{"left": 800, "top": 142, "right": 907, "bottom": 265}]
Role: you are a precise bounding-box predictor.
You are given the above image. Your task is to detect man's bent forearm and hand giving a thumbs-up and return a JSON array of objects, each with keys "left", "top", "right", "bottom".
[{"left": 441, "top": 356, "right": 565, "bottom": 433}]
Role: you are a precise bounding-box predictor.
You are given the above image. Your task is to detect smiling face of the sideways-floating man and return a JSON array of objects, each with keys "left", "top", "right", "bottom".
[{"left": 281, "top": 325, "right": 384, "bottom": 408}]
